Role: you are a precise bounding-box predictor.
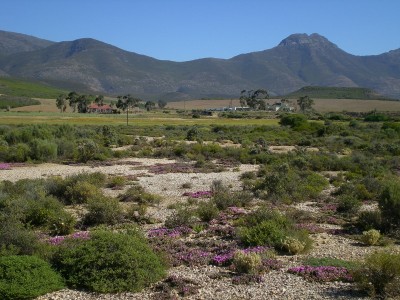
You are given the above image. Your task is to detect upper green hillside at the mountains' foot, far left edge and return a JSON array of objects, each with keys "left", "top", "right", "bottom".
[{"left": 0, "top": 77, "right": 66, "bottom": 99}]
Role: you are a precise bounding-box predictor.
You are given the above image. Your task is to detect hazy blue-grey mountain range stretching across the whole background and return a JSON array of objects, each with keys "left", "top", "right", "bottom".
[{"left": 0, "top": 31, "right": 400, "bottom": 101}]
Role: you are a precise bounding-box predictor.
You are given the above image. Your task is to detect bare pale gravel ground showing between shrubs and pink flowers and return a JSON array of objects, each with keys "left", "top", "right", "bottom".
[{"left": 0, "top": 158, "right": 400, "bottom": 300}]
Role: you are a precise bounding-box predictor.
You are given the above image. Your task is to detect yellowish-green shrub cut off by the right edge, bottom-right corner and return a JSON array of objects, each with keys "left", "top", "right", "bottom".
[{"left": 354, "top": 252, "right": 400, "bottom": 298}]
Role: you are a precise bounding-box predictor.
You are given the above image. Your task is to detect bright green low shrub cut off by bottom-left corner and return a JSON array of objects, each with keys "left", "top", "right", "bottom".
[{"left": 0, "top": 256, "right": 64, "bottom": 300}]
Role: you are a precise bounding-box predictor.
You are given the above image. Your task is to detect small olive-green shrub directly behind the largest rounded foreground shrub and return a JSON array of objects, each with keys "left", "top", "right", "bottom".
[{"left": 84, "top": 196, "right": 124, "bottom": 225}]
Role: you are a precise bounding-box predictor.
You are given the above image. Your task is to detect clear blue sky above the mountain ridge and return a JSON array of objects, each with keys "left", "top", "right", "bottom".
[{"left": 0, "top": 0, "right": 400, "bottom": 61}]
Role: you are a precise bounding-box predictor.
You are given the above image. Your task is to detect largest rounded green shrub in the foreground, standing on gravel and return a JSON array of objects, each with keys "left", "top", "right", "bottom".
[{"left": 53, "top": 231, "right": 166, "bottom": 293}]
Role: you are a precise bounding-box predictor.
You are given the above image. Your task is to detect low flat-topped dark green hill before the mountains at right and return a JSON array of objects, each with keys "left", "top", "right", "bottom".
[{"left": 285, "top": 86, "right": 395, "bottom": 100}]
